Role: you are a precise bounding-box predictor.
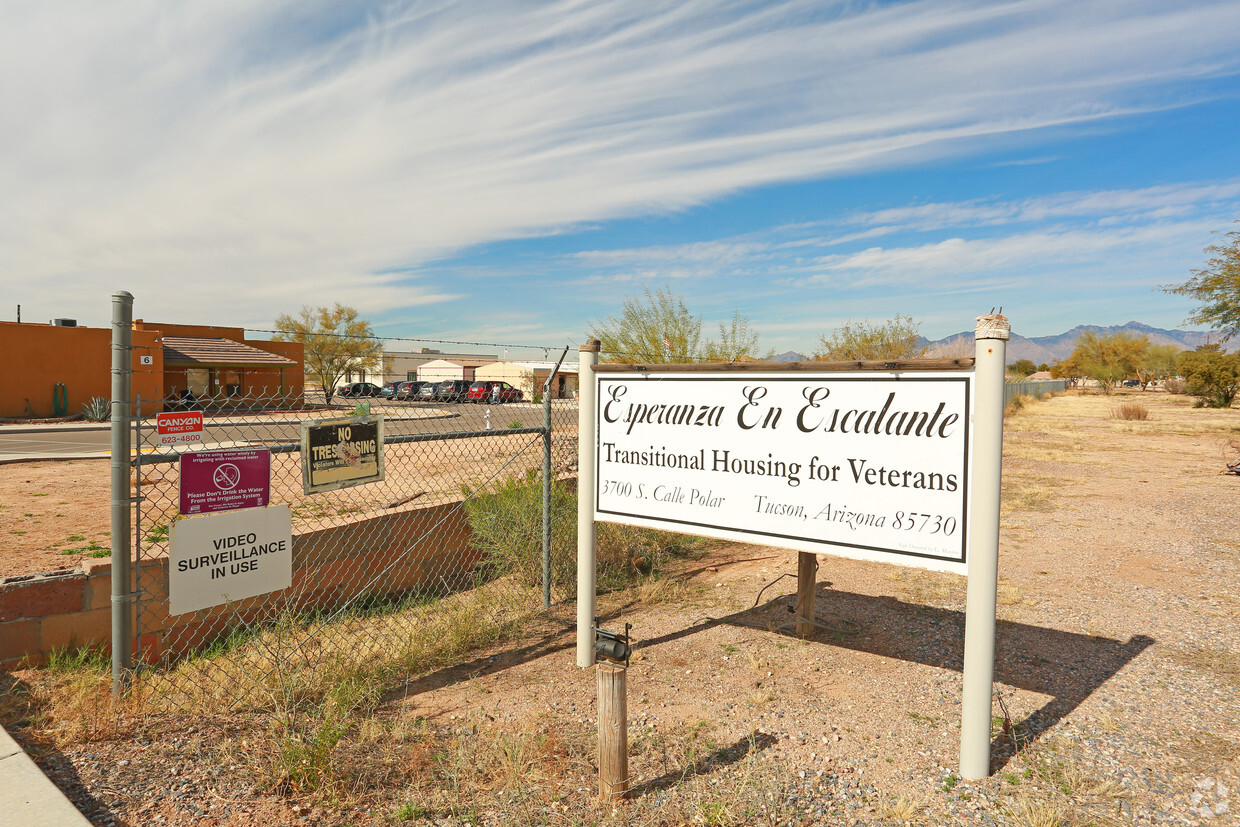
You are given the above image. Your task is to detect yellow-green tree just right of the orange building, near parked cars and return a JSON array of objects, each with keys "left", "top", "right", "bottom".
[{"left": 275, "top": 301, "right": 383, "bottom": 402}]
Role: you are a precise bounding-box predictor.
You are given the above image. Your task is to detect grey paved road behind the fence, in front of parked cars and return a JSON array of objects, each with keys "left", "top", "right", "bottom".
[{"left": 0, "top": 403, "right": 575, "bottom": 461}]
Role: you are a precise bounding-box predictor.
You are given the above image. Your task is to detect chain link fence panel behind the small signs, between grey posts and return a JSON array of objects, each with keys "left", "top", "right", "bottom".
[{"left": 131, "top": 381, "right": 577, "bottom": 712}]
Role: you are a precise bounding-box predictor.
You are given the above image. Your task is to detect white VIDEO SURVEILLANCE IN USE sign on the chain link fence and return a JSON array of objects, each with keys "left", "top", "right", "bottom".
[{"left": 167, "top": 506, "right": 293, "bottom": 615}]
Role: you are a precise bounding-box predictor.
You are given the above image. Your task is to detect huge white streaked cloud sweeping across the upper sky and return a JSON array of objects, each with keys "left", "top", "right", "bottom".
[{"left": 0, "top": 0, "right": 1240, "bottom": 322}]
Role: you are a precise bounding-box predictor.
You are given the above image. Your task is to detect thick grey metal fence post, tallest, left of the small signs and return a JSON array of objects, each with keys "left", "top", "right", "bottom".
[{"left": 112, "top": 290, "right": 134, "bottom": 697}]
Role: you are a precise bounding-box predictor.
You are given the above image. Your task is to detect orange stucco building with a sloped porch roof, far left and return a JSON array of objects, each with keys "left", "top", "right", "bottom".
[{"left": 0, "top": 319, "right": 305, "bottom": 419}]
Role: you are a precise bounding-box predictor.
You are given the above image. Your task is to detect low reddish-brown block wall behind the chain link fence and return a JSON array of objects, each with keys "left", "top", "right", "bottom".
[{"left": 0, "top": 502, "right": 479, "bottom": 670}]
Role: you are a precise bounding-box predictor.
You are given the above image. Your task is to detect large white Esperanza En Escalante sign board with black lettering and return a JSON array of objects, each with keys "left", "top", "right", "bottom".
[{"left": 594, "top": 372, "right": 973, "bottom": 574}]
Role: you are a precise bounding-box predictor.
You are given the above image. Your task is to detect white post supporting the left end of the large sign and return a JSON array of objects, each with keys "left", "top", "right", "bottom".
[{"left": 577, "top": 338, "right": 600, "bottom": 668}]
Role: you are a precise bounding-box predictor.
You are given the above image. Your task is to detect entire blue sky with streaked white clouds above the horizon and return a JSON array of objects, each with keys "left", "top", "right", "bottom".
[{"left": 0, "top": 0, "right": 1240, "bottom": 355}]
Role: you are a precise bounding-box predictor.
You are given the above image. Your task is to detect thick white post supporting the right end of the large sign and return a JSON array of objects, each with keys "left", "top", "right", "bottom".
[{"left": 960, "top": 312, "right": 1012, "bottom": 779}]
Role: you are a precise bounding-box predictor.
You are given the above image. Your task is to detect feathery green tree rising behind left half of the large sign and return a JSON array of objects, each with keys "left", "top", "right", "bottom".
[{"left": 590, "top": 286, "right": 759, "bottom": 365}]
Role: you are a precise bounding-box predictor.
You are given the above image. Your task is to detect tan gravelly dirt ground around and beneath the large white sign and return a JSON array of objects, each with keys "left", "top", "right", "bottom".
[{"left": 0, "top": 393, "right": 1240, "bottom": 827}]
